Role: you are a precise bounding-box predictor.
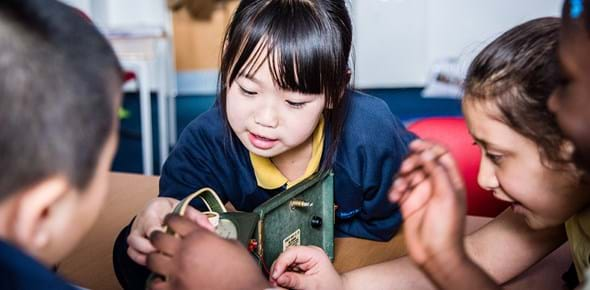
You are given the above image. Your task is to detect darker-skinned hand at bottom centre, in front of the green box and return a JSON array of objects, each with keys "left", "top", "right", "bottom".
[{"left": 147, "top": 215, "right": 269, "bottom": 290}]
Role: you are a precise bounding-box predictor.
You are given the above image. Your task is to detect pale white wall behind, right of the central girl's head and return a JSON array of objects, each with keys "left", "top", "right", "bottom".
[{"left": 352, "top": 0, "right": 562, "bottom": 88}]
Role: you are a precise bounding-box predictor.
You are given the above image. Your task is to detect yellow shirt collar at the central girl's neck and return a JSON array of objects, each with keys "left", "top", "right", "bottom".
[{"left": 250, "top": 118, "right": 324, "bottom": 189}]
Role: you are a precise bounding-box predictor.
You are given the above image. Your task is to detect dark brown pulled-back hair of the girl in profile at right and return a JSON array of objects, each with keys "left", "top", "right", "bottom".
[{"left": 464, "top": 17, "right": 570, "bottom": 166}]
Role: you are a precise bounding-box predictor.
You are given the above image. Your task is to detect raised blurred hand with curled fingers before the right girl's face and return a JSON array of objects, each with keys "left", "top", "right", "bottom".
[{"left": 389, "top": 140, "right": 465, "bottom": 267}]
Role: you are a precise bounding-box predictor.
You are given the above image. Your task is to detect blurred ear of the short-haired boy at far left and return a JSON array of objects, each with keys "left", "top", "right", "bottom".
[{"left": 11, "top": 177, "right": 70, "bottom": 255}]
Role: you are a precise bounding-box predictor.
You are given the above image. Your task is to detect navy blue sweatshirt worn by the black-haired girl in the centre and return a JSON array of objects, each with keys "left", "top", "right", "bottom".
[{"left": 160, "top": 92, "right": 415, "bottom": 241}]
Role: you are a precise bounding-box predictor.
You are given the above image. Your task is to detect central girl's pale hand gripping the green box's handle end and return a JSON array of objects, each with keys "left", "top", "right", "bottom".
[{"left": 127, "top": 197, "right": 213, "bottom": 266}]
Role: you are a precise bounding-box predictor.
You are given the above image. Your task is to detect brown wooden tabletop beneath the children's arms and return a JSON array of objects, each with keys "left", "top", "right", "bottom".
[{"left": 58, "top": 173, "right": 412, "bottom": 290}]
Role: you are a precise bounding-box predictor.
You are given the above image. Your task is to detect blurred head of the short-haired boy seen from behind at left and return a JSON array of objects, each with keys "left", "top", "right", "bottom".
[{"left": 0, "top": 0, "right": 122, "bottom": 264}]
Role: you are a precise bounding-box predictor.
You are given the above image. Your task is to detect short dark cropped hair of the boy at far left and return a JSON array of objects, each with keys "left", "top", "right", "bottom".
[{"left": 0, "top": 0, "right": 122, "bottom": 199}]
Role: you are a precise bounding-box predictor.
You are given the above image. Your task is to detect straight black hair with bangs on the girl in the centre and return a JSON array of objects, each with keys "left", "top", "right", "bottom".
[{"left": 219, "top": 0, "right": 352, "bottom": 168}]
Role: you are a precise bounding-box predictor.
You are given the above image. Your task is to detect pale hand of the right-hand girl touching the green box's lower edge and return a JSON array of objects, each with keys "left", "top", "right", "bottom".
[{"left": 270, "top": 246, "right": 343, "bottom": 289}]
